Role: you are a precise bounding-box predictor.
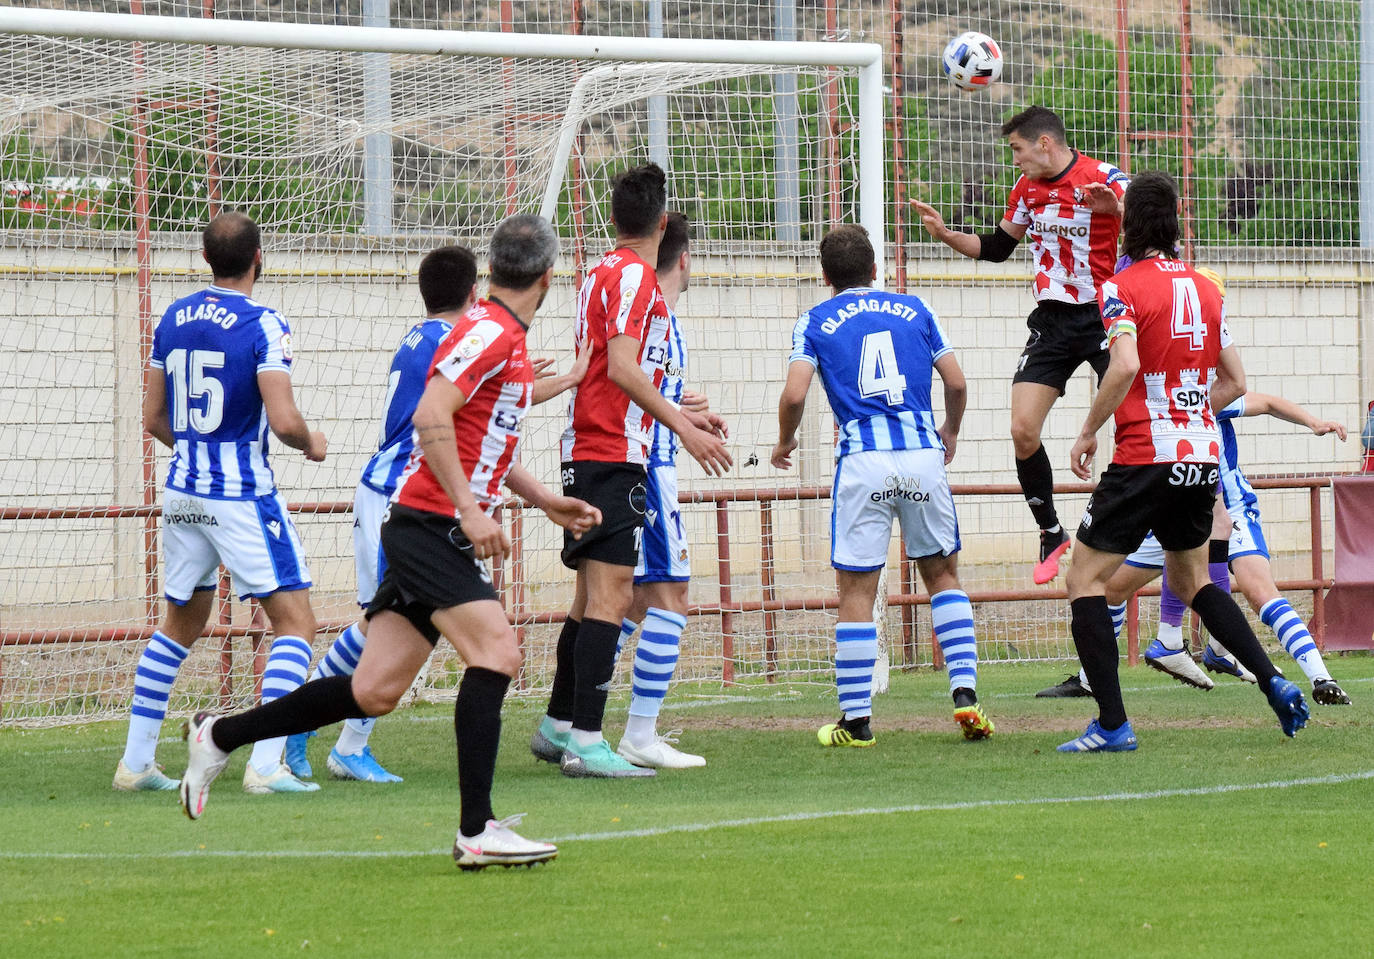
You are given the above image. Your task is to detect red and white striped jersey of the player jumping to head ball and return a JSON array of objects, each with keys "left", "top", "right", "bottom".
[{"left": 1004, "top": 150, "right": 1127, "bottom": 304}]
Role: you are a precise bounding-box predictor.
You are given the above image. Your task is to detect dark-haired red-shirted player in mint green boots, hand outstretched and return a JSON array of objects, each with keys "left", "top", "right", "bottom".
[{"left": 530, "top": 163, "right": 731, "bottom": 778}]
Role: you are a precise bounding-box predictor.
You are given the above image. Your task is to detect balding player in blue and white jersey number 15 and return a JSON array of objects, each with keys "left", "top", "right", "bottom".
[{"left": 114, "top": 213, "right": 327, "bottom": 794}]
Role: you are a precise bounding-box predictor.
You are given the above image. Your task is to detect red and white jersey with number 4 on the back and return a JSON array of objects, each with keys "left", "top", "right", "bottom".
[{"left": 1099, "top": 258, "right": 1231, "bottom": 466}]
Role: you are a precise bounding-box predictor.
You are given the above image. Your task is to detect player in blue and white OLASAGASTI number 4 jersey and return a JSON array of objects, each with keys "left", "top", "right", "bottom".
[{"left": 772, "top": 225, "right": 993, "bottom": 746}]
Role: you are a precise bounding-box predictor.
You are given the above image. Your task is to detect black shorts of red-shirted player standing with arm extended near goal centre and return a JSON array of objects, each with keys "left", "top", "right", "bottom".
[{"left": 562, "top": 460, "right": 647, "bottom": 569}]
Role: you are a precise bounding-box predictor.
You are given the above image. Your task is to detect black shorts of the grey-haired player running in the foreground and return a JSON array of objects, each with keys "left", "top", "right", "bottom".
[{"left": 367, "top": 503, "right": 500, "bottom": 643}]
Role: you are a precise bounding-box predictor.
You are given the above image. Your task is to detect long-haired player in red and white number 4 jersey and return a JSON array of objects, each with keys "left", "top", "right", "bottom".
[{"left": 1059, "top": 172, "right": 1308, "bottom": 753}]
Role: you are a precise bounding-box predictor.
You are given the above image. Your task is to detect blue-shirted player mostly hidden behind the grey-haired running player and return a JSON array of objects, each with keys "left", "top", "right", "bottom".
[{"left": 286, "top": 246, "right": 587, "bottom": 783}]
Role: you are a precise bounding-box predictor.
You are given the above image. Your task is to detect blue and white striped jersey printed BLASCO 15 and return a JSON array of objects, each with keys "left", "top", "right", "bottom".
[{"left": 148, "top": 286, "right": 291, "bottom": 500}]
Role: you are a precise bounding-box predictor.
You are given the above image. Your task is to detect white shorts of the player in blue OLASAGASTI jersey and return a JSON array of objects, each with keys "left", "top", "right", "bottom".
[{"left": 830, "top": 449, "right": 960, "bottom": 573}]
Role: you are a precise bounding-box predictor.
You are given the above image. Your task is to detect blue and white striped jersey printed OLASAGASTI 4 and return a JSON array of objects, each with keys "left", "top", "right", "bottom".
[{"left": 791, "top": 287, "right": 952, "bottom": 458}]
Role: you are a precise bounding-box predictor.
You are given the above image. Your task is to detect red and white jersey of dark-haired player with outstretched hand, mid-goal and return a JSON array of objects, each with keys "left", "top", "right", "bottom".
[{"left": 562, "top": 247, "right": 668, "bottom": 463}]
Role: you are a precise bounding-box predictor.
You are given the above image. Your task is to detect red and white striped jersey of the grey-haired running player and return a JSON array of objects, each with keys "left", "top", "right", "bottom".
[{"left": 393, "top": 300, "right": 534, "bottom": 517}]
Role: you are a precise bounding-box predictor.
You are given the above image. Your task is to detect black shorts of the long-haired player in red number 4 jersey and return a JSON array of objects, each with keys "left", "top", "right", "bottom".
[{"left": 1079, "top": 463, "right": 1219, "bottom": 555}]
